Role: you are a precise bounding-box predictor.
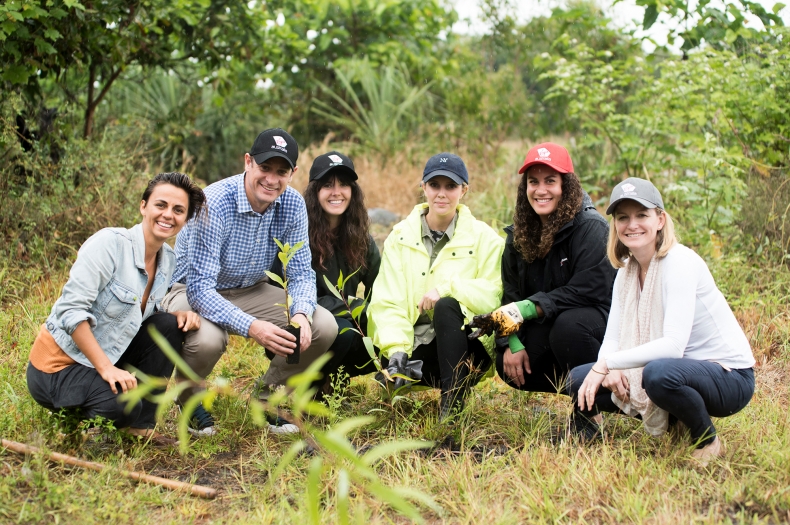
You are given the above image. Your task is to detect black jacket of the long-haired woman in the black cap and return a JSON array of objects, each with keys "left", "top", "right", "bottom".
[{"left": 313, "top": 236, "right": 381, "bottom": 319}]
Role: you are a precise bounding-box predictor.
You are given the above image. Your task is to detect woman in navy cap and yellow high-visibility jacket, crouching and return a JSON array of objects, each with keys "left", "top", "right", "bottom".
[{"left": 369, "top": 153, "right": 504, "bottom": 420}]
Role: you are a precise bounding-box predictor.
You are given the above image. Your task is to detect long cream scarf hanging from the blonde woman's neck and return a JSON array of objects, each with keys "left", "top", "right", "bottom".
[{"left": 612, "top": 255, "right": 669, "bottom": 436}]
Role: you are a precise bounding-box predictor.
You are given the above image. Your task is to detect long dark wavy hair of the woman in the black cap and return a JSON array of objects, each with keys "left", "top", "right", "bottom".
[{"left": 304, "top": 172, "right": 370, "bottom": 270}]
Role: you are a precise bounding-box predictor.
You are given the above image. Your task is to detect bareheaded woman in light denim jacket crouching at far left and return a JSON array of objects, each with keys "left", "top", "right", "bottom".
[{"left": 27, "top": 173, "right": 205, "bottom": 442}]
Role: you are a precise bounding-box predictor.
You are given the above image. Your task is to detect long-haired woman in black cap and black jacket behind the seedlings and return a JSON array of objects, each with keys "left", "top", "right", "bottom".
[{"left": 304, "top": 151, "right": 381, "bottom": 395}]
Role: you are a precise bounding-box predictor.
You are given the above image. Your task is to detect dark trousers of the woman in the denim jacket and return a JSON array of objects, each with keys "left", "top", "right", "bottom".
[{"left": 27, "top": 313, "right": 184, "bottom": 428}]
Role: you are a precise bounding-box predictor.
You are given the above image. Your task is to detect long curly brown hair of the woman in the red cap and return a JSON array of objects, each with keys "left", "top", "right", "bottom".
[{"left": 513, "top": 170, "right": 584, "bottom": 263}]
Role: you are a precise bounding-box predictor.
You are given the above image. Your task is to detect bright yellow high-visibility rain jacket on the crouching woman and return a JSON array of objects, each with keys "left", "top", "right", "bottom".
[{"left": 368, "top": 204, "right": 505, "bottom": 357}]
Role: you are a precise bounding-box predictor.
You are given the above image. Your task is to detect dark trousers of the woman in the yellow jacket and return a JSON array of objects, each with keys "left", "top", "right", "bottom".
[{"left": 411, "top": 297, "right": 491, "bottom": 398}]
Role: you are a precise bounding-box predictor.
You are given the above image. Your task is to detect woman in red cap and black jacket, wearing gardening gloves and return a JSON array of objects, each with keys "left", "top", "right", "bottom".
[{"left": 472, "top": 142, "right": 615, "bottom": 393}]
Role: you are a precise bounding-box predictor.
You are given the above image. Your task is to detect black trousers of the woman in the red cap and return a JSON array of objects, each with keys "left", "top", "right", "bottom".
[{"left": 496, "top": 308, "right": 606, "bottom": 394}]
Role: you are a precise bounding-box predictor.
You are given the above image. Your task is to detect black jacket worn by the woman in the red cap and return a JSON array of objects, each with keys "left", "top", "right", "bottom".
[{"left": 502, "top": 193, "right": 617, "bottom": 330}]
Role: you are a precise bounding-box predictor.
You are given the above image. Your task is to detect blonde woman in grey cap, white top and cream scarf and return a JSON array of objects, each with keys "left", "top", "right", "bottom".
[{"left": 569, "top": 178, "right": 755, "bottom": 464}]
